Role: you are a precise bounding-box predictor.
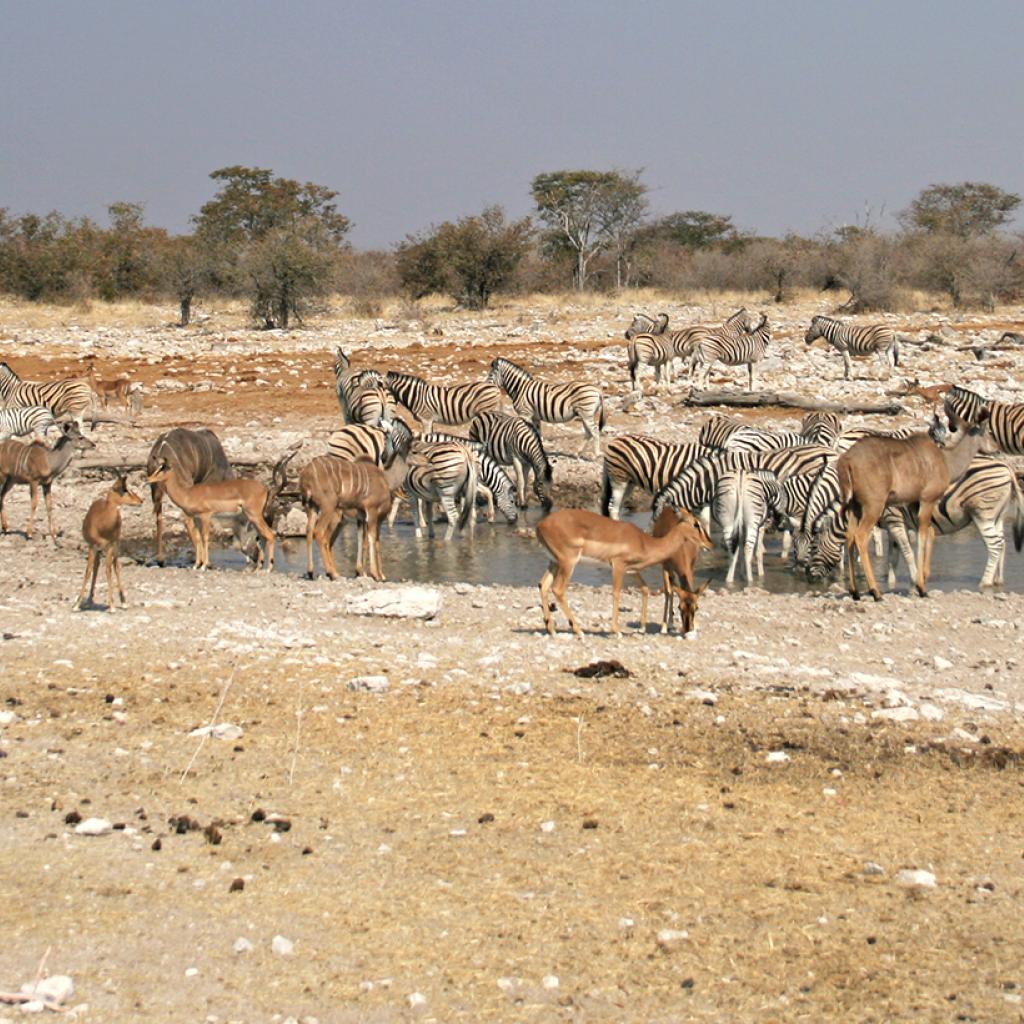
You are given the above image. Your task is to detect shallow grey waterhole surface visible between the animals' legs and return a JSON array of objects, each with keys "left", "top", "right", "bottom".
[{"left": 122, "top": 508, "right": 1024, "bottom": 593}]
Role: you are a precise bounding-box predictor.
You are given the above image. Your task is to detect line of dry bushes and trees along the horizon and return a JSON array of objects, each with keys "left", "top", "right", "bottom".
[{"left": 0, "top": 167, "right": 1024, "bottom": 319}]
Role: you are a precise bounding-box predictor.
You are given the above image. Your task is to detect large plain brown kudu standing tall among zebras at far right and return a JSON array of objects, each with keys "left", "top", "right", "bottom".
[{"left": 836, "top": 416, "right": 998, "bottom": 601}]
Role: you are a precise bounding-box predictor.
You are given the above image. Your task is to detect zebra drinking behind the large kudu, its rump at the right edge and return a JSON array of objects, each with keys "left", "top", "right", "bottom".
[{"left": 807, "top": 456, "right": 1024, "bottom": 587}]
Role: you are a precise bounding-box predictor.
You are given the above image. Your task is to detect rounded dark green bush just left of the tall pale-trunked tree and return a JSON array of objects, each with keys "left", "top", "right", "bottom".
[{"left": 397, "top": 206, "right": 532, "bottom": 309}]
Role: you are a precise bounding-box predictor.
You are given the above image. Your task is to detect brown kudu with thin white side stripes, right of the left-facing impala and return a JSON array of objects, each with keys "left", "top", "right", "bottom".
[{"left": 299, "top": 455, "right": 406, "bottom": 583}]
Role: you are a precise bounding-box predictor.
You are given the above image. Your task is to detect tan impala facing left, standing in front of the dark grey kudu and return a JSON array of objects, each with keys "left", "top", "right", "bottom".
[{"left": 146, "top": 459, "right": 276, "bottom": 572}]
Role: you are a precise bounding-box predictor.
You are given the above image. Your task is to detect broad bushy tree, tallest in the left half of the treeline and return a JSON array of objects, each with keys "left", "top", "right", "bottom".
[{"left": 194, "top": 166, "right": 351, "bottom": 328}]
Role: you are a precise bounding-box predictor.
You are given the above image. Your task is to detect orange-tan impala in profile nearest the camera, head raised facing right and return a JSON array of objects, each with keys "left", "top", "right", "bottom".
[{"left": 537, "top": 509, "right": 707, "bottom": 637}]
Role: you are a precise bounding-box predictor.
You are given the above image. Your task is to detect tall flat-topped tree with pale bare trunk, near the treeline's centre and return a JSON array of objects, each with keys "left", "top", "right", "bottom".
[{"left": 530, "top": 171, "right": 647, "bottom": 290}]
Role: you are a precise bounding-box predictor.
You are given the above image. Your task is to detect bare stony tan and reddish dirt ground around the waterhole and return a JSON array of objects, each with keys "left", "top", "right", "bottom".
[{"left": 0, "top": 299, "right": 1024, "bottom": 1022}]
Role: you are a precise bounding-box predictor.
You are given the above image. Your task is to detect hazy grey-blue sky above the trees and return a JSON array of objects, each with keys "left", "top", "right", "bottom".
[{"left": 0, "top": 0, "right": 1024, "bottom": 248}]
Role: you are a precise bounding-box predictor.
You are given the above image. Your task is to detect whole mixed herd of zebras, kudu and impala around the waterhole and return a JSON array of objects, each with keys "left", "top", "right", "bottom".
[{"left": 0, "top": 309, "right": 1024, "bottom": 635}]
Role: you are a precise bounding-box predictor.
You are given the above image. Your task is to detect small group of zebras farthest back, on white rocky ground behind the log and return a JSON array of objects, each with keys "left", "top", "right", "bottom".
[{"left": 626, "top": 309, "right": 899, "bottom": 391}]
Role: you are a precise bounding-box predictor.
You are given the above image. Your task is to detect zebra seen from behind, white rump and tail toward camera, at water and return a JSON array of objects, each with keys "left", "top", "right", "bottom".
[{"left": 712, "top": 469, "right": 785, "bottom": 583}]
